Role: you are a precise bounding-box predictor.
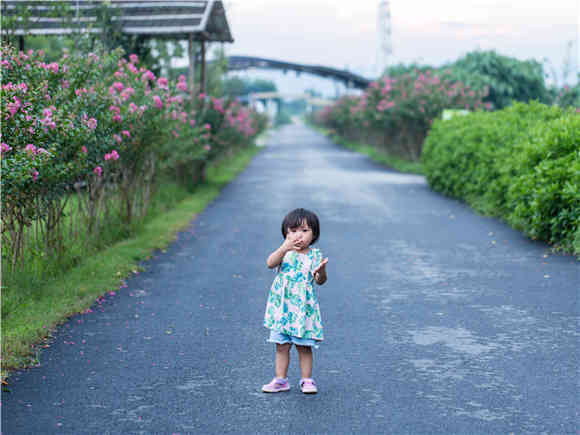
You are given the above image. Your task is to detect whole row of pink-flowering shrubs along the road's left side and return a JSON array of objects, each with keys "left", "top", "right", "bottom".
[{"left": 0, "top": 46, "right": 266, "bottom": 265}]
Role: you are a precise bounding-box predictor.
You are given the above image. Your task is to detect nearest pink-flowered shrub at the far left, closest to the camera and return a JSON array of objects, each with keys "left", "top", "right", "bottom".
[{"left": 0, "top": 47, "right": 94, "bottom": 230}]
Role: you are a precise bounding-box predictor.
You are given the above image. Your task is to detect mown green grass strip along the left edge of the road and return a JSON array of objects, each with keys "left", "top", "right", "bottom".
[{"left": 1, "top": 146, "right": 260, "bottom": 380}]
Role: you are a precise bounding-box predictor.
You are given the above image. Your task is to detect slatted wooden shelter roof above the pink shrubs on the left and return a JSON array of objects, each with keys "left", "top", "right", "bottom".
[{"left": 1, "top": 0, "right": 233, "bottom": 42}]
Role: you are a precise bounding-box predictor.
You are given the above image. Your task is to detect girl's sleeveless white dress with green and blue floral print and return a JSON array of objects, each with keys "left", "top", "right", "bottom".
[{"left": 264, "top": 248, "right": 324, "bottom": 341}]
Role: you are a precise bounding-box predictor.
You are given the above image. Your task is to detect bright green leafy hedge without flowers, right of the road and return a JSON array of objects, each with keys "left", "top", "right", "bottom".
[{"left": 422, "top": 102, "right": 580, "bottom": 254}]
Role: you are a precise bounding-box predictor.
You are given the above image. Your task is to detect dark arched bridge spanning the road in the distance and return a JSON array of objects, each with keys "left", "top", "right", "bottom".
[{"left": 227, "top": 56, "right": 371, "bottom": 89}]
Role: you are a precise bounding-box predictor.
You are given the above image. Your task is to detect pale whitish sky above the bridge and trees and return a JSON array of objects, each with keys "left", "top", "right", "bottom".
[{"left": 212, "top": 0, "right": 580, "bottom": 95}]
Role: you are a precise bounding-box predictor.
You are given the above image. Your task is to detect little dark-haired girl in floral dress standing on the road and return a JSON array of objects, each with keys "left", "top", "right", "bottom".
[{"left": 262, "top": 208, "right": 328, "bottom": 394}]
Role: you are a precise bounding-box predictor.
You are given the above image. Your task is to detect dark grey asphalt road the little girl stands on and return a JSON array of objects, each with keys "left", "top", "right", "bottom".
[{"left": 2, "top": 125, "right": 580, "bottom": 434}]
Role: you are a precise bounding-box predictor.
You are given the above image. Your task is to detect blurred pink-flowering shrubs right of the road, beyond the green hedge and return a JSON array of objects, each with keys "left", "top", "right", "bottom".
[{"left": 317, "top": 71, "right": 491, "bottom": 160}]
